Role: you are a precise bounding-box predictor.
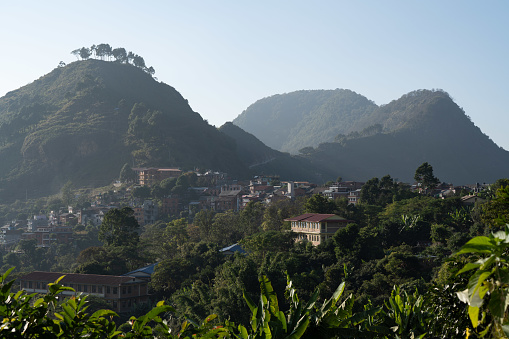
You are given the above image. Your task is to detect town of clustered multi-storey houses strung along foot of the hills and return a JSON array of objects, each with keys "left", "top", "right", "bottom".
[{"left": 0, "top": 167, "right": 488, "bottom": 250}]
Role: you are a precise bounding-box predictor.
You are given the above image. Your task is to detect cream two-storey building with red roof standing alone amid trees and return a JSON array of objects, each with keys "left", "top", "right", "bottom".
[{"left": 285, "top": 213, "right": 352, "bottom": 246}]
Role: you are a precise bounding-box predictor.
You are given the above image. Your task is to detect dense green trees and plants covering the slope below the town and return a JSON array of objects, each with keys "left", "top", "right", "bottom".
[{"left": 3, "top": 171, "right": 509, "bottom": 338}]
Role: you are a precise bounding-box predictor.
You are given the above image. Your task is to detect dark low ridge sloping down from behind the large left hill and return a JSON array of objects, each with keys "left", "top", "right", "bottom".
[{"left": 219, "top": 122, "right": 336, "bottom": 183}]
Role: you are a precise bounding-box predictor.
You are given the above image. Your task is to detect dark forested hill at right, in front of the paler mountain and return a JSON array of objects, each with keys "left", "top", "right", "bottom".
[{"left": 306, "top": 90, "right": 509, "bottom": 184}]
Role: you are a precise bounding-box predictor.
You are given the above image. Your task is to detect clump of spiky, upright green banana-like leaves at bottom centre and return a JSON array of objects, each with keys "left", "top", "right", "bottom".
[{"left": 235, "top": 276, "right": 389, "bottom": 339}]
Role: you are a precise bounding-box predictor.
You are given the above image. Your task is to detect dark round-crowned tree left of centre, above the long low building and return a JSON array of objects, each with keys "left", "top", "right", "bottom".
[{"left": 99, "top": 207, "right": 140, "bottom": 246}]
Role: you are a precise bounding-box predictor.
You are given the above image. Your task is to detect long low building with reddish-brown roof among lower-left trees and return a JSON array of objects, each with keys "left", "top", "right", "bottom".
[{"left": 18, "top": 271, "right": 148, "bottom": 313}]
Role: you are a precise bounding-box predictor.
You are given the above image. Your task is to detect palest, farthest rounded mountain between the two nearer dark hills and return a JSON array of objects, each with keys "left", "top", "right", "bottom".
[{"left": 233, "top": 89, "right": 378, "bottom": 154}]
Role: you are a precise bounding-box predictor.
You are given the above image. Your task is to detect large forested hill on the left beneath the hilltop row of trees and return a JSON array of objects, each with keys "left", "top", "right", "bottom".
[{"left": 0, "top": 60, "right": 247, "bottom": 202}]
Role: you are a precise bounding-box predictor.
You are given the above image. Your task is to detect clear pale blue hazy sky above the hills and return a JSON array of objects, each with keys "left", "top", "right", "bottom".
[{"left": 0, "top": 0, "right": 509, "bottom": 150}]
